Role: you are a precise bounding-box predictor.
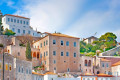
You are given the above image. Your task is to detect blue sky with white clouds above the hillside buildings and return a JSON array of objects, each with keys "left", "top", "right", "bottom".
[{"left": 0, "top": 0, "right": 120, "bottom": 42}]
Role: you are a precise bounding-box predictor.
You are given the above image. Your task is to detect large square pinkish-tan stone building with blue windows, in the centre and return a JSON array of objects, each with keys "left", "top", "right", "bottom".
[{"left": 33, "top": 33, "right": 80, "bottom": 73}]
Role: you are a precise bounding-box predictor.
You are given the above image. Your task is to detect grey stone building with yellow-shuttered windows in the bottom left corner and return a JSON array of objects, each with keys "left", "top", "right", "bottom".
[{"left": 0, "top": 53, "right": 32, "bottom": 80}]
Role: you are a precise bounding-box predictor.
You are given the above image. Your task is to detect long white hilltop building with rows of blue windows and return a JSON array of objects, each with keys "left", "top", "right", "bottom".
[{"left": 2, "top": 14, "right": 41, "bottom": 37}]
